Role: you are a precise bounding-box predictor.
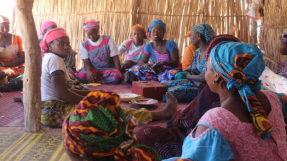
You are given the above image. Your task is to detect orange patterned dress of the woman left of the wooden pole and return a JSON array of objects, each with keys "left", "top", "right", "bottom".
[{"left": 0, "top": 35, "right": 24, "bottom": 77}]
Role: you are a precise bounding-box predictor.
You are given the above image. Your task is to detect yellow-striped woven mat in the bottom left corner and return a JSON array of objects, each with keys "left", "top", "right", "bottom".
[{"left": 0, "top": 133, "right": 69, "bottom": 161}]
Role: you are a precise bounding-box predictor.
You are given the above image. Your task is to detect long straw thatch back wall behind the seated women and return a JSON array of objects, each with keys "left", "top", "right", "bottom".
[{"left": 12, "top": 0, "right": 257, "bottom": 67}]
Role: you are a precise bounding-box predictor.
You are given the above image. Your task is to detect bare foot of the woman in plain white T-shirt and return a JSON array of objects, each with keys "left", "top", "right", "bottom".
[{"left": 151, "top": 93, "right": 177, "bottom": 121}]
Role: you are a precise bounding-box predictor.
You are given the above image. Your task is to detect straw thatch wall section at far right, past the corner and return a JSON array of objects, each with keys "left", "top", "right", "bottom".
[{"left": 259, "top": 0, "right": 287, "bottom": 69}]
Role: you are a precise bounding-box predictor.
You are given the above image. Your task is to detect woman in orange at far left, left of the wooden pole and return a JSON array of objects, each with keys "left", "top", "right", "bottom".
[{"left": 0, "top": 15, "right": 25, "bottom": 78}]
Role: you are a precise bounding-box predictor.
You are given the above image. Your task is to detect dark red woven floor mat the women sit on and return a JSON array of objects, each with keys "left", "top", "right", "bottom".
[{"left": 0, "top": 84, "right": 191, "bottom": 132}]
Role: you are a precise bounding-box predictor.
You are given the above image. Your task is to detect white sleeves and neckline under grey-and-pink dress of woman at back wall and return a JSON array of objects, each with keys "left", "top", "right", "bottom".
[{"left": 80, "top": 35, "right": 120, "bottom": 60}]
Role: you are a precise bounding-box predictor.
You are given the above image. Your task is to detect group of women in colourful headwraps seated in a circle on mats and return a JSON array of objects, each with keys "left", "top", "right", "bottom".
[{"left": 1, "top": 14, "right": 287, "bottom": 160}]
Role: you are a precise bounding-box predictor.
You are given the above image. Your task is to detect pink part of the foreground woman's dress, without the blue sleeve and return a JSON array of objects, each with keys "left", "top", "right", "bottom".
[{"left": 196, "top": 91, "right": 287, "bottom": 161}]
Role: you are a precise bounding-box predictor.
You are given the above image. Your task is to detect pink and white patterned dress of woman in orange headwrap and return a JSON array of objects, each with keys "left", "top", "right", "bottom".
[{"left": 119, "top": 39, "right": 151, "bottom": 65}]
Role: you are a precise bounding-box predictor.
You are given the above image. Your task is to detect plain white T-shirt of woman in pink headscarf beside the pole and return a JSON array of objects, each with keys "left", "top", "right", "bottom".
[{"left": 41, "top": 53, "right": 70, "bottom": 101}]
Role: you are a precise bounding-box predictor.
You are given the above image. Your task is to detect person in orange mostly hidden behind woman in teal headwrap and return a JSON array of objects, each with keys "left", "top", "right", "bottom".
[{"left": 182, "top": 32, "right": 197, "bottom": 71}]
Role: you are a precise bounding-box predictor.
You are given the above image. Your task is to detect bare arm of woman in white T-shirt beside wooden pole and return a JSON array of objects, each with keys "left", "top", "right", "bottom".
[{"left": 51, "top": 70, "right": 84, "bottom": 103}]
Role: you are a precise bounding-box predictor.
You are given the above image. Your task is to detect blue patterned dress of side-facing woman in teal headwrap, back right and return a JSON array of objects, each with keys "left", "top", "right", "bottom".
[{"left": 162, "top": 48, "right": 206, "bottom": 102}]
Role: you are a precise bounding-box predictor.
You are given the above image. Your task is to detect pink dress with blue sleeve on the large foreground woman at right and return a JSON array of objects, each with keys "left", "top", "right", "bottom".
[{"left": 165, "top": 91, "right": 287, "bottom": 161}]
